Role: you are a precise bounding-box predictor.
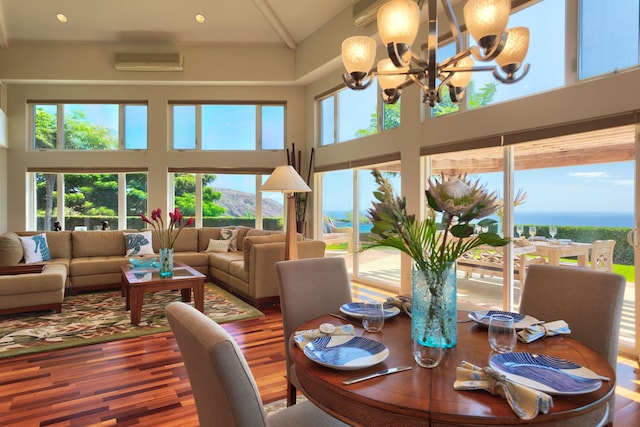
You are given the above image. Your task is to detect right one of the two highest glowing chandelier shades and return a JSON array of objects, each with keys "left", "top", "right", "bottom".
[{"left": 463, "top": 0, "right": 511, "bottom": 41}]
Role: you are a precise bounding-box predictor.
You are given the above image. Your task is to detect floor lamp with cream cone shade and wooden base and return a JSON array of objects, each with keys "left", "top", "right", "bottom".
[{"left": 260, "top": 166, "right": 311, "bottom": 260}]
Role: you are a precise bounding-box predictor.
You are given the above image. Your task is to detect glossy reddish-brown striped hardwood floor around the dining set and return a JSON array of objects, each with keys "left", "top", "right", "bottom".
[{"left": 0, "top": 296, "right": 640, "bottom": 427}]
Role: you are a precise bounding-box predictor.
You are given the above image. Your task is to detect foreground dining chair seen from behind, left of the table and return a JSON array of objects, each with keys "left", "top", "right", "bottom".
[{"left": 165, "top": 301, "right": 346, "bottom": 427}]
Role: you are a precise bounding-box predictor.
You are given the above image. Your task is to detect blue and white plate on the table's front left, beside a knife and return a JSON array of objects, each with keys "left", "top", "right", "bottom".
[{"left": 303, "top": 335, "right": 389, "bottom": 371}]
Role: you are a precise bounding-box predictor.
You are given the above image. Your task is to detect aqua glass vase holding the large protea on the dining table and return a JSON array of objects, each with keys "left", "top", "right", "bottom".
[{"left": 411, "top": 262, "right": 458, "bottom": 348}]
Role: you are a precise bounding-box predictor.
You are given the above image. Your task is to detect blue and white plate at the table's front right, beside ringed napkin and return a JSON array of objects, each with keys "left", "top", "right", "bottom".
[{"left": 489, "top": 353, "right": 602, "bottom": 395}]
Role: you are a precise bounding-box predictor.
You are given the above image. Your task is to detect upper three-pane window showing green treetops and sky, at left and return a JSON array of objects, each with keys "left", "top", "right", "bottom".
[{"left": 32, "top": 104, "right": 147, "bottom": 151}]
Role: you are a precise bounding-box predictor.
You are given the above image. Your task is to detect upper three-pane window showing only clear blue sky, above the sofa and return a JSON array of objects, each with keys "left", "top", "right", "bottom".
[{"left": 171, "top": 104, "right": 285, "bottom": 151}]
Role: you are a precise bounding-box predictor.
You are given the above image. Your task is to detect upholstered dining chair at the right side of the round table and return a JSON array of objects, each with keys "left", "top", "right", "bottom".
[{"left": 519, "top": 265, "right": 626, "bottom": 423}]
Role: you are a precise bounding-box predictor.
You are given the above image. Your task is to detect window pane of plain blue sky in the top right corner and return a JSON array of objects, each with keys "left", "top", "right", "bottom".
[{"left": 578, "top": 0, "right": 640, "bottom": 79}]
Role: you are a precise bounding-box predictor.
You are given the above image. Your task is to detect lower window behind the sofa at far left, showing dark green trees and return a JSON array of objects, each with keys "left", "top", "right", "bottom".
[{"left": 32, "top": 173, "right": 147, "bottom": 230}]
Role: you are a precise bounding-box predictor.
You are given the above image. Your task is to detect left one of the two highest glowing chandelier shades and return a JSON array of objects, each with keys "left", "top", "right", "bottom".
[{"left": 378, "top": 0, "right": 420, "bottom": 46}]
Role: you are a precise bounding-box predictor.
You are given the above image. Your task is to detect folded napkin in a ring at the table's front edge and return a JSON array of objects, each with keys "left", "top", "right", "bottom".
[{"left": 453, "top": 361, "right": 553, "bottom": 420}]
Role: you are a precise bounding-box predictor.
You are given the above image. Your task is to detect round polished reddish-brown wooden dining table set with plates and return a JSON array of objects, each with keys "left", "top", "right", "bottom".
[{"left": 289, "top": 312, "right": 615, "bottom": 426}]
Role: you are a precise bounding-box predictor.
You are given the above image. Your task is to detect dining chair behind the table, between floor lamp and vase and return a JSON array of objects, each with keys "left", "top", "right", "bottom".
[{"left": 276, "top": 257, "right": 352, "bottom": 406}]
